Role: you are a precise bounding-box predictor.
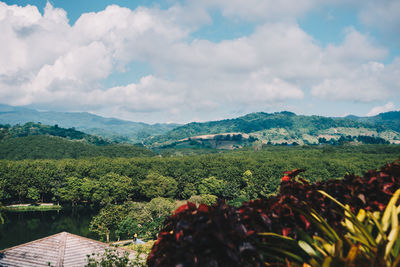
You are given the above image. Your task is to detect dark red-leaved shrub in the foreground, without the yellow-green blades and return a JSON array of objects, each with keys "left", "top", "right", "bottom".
[{"left": 148, "top": 162, "right": 400, "bottom": 266}]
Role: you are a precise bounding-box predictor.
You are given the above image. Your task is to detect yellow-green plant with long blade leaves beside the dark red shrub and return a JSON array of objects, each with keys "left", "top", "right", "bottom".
[{"left": 260, "top": 189, "right": 400, "bottom": 267}]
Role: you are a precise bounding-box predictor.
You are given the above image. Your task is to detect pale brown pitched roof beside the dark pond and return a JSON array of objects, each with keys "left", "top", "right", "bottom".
[{"left": 0, "top": 232, "right": 132, "bottom": 267}]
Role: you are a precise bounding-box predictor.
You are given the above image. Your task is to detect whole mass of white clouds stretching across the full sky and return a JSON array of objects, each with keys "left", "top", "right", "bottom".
[{"left": 0, "top": 0, "right": 400, "bottom": 122}]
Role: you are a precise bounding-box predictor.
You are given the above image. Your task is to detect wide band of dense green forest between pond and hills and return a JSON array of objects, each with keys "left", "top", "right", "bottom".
[{"left": 0, "top": 145, "right": 400, "bottom": 205}]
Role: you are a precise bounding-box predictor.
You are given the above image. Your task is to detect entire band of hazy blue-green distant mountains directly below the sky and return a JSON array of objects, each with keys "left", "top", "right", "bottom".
[{"left": 0, "top": 105, "right": 400, "bottom": 149}]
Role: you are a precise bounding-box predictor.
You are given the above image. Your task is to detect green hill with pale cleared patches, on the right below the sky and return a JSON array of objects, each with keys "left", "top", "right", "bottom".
[{"left": 145, "top": 111, "right": 400, "bottom": 146}]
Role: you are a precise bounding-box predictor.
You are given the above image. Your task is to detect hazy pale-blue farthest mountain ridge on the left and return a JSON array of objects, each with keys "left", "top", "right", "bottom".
[{"left": 0, "top": 104, "right": 178, "bottom": 143}]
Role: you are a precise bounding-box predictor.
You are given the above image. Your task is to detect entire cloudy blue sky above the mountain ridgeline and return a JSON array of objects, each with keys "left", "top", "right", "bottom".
[{"left": 0, "top": 0, "right": 400, "bottom": 123}]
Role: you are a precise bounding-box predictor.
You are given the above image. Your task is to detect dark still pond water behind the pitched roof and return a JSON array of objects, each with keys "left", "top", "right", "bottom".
[{"left": 0, "top": 208, "right": 98, "bottom": 249}]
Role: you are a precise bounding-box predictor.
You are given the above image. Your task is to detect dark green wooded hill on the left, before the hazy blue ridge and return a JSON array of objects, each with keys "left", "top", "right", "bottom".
[{"left": 0, "top": 122, "right": 154, "bottom": 160}]
